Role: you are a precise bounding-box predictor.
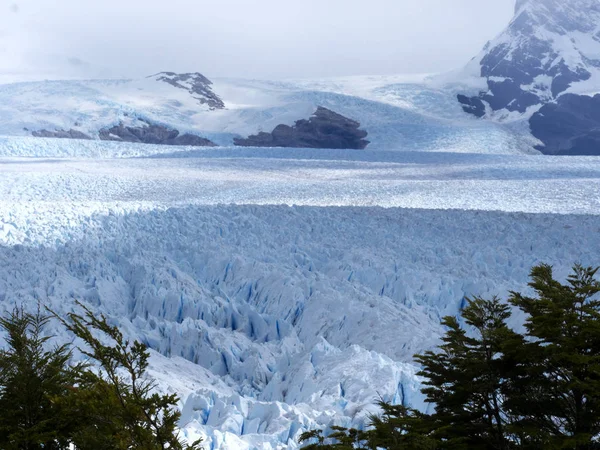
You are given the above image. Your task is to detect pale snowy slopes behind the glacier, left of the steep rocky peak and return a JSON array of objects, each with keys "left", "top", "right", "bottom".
[{"left": 0, "top": 73, "right": 533, "bottom": 153}]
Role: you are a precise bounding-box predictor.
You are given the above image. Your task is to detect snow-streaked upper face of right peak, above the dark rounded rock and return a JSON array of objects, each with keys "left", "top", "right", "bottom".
[{"left": 465, "top": 0, "right": 600, "bottom": 113}]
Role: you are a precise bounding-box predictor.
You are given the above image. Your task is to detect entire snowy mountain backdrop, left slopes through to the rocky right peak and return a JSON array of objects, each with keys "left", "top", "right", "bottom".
[{"left": 0, "top": 0, "right": 600, "bottom": 154}]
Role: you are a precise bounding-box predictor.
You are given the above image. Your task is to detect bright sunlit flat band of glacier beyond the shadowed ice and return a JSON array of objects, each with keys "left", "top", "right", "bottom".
[{"left": 0, "top": 144, "right": 600, "bottom": 216}]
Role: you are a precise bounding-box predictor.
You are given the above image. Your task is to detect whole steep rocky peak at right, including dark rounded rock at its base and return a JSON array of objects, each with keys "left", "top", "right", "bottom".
[{"left": 458, "top": 0, "right": 600, "bottom": 154}]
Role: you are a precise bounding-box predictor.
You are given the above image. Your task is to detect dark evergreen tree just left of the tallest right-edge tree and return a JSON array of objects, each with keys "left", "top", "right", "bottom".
[{"left": 416, "top": 298, "right": 522, "bottom": 450}]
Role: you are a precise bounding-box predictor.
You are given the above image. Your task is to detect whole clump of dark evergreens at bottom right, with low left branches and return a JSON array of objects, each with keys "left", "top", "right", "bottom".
[{"left": 302, "top": 265, "right": 600, "bottom": 450}]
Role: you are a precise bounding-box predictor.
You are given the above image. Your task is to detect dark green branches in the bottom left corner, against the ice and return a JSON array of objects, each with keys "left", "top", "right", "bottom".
[{"left": 0, "top": 302, "right": 200, "bottom": 450}]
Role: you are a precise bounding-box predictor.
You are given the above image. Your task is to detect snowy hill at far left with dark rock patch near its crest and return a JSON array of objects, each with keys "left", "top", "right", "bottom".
[{"left": 0, "top": 73, "right": 223, "bottom": 139}]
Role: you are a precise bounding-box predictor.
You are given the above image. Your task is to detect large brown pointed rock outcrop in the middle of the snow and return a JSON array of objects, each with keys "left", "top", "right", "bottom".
[{"left": 234, "top": 107, "right": 369, "bottom": 150}]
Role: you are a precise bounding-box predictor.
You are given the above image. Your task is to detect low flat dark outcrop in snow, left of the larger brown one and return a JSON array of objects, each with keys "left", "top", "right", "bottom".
[{"left": 99, "top": 121, "right": 215, "bottom": 147}]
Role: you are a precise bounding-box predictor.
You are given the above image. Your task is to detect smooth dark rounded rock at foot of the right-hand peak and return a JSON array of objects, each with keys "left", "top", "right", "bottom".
[{"left": 529, "top": 94, "right": 600, "bottom": 155}]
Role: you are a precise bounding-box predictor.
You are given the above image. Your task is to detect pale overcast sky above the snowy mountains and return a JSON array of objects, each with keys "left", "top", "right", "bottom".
[{"left": 0, "top": 0, "right": 515, "bottom": 78}]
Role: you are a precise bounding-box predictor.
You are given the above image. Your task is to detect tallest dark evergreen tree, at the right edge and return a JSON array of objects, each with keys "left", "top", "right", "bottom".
[{"left": 510, "top": 265, "right": 600, "bottom": 450}]
